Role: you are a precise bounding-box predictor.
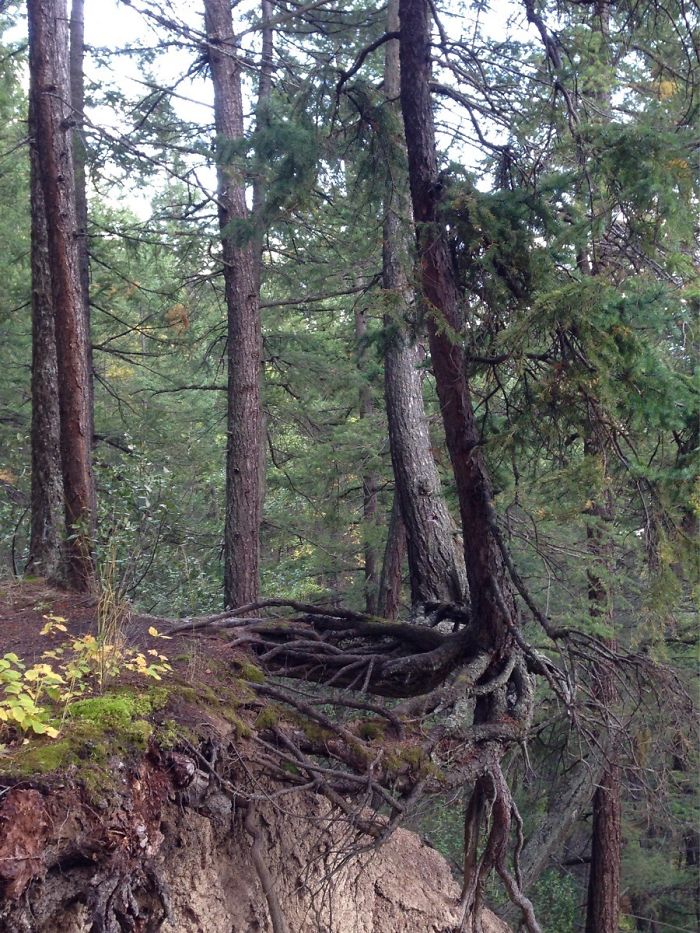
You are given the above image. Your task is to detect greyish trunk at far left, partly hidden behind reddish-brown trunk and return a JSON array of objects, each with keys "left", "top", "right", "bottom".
[{"left": 27, "top": 93, "right": 63, "bottom": 578}]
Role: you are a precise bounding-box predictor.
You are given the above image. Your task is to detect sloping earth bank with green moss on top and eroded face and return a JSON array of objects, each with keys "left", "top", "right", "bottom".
[{"left": 0, "top": 587, "right": 508, "bottom": 933}]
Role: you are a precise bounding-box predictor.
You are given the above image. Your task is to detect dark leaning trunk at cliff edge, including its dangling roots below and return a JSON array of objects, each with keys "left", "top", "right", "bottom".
[{"left": 399, "top": 0, "right": 540, "bottom": 933}]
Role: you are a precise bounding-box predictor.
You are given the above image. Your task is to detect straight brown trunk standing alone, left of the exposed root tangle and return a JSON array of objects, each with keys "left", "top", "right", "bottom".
[{"left": 204, "top": 0, "right": 263, "bottom": 607}]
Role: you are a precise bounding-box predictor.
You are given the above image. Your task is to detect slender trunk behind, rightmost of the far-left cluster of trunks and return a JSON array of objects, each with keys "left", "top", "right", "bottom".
[{"left": 70, "top": 0, "right": 97, "bottom": 516}]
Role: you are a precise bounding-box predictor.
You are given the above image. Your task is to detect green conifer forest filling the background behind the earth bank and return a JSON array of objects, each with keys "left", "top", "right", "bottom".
[{"left": 0, "top": 0, "right": 700, "bottom": 933}]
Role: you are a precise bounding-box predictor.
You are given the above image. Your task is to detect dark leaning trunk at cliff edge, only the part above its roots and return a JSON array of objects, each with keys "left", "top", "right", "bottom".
[{"left": 400, "top": 0, "right": 517, "bottom": 651}]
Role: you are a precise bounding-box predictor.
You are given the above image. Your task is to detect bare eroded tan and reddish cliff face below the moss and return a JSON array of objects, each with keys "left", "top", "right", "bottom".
[{"left": 0, "top": 750, "right": 508, "bottom": 933}]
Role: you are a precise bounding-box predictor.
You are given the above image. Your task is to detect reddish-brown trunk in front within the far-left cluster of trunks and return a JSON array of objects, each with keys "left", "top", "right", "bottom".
[{"left": 28, "top": 0, "right": 94, "bottom": 591}]
